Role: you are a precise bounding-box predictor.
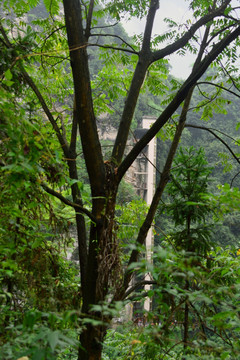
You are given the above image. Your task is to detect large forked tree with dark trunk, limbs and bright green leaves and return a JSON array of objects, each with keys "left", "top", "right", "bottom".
[{"left": 0, "top": 0, "right": 240, "bottom": 360}]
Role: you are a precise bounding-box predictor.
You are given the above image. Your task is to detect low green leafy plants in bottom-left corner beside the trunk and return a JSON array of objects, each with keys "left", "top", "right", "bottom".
[{"left": 0, "top": 310, "right": 78, "bottom": 360}]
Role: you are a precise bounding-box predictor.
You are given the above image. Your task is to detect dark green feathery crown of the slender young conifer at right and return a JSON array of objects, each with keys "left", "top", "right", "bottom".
[{"left": 163, "top": 147, "right": 214, "bottom": 253}]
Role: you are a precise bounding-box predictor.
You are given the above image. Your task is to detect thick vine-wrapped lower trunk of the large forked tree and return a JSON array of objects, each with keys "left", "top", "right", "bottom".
[{"left": 78, "top": 181, "right": 117, "bottom": 360}]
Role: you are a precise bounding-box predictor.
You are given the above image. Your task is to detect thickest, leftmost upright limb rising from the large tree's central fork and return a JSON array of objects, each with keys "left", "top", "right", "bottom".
[{"left": 63, "top": 0, "right": 105, "bottom": 202}]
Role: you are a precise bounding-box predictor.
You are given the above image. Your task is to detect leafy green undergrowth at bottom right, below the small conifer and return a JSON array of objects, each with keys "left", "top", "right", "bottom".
[{"left": 103, "top": 243, "right": 240, "bottom": 360}]
